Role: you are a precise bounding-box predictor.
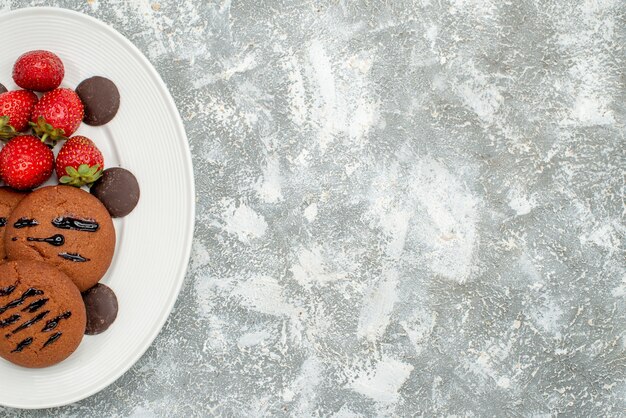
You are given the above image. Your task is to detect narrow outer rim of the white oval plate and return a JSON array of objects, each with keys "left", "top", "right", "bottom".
[{"left": 0, "top": 6, "right": 196, "bottom": 410}]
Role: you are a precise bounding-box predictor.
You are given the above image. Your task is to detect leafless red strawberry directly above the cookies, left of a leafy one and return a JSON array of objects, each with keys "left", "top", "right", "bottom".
[{"left": 0, "top": 135, "right": 54, "bottom": 190}]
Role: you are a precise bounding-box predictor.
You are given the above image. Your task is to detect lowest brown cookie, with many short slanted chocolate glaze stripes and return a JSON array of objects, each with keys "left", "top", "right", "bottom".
[{"left": 0, "top": 260, "right": 87, "bottom": 367}]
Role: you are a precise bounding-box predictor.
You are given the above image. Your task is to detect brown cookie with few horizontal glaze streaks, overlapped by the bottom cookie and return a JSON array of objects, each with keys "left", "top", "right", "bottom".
[{"left": 4, "top": 186, "right": 115, "bottom": 292}]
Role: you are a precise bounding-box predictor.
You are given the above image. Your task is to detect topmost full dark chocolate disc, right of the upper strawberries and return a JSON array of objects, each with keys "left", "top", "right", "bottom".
[{"left": 76, "top": 76, "right": 120, "bottom": 126}]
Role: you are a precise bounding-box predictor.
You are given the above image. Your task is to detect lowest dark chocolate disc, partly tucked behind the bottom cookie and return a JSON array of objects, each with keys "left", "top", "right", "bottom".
[{"left": 82, "top": 283, "right": 117, "bottom": 335}]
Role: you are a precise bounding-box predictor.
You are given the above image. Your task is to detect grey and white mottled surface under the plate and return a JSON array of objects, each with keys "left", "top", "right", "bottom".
[{"left": 0, "top": 0, "right": 626, "bottom": 418}]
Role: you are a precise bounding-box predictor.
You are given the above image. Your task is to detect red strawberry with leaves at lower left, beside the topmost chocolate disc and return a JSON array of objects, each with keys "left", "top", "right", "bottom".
[{"left": 31, "top": 89, "right": 85, "bottom": 142}]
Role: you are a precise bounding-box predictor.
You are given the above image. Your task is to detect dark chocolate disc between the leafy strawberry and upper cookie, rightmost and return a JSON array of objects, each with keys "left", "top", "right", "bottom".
[{"left": 90, "top": 167, "right": 139, "bottom": 218}]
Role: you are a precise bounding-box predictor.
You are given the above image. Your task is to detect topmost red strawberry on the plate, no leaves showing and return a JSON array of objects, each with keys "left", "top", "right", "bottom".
[{"left": 13, "top": 50, "right": 65, "bottom": 91}]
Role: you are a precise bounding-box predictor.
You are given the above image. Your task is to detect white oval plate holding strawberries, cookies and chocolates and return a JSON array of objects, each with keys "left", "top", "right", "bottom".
[{"left": 0, "top": 8, "right": 195, "bottom": 408}]
